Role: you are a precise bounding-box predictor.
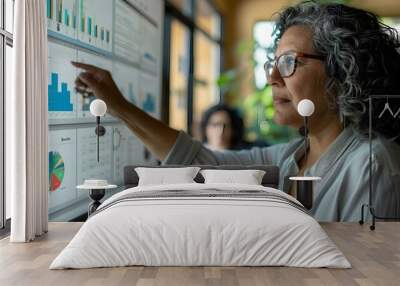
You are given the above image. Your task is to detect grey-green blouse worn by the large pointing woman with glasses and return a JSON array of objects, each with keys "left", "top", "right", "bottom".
[{"left": 163, "top": 127, "right": 400, "bottom": 221}]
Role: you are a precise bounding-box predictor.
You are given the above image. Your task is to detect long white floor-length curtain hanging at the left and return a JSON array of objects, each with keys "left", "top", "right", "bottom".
[{"left": 6, "top": 0, "right": 48, "bottom": 242}]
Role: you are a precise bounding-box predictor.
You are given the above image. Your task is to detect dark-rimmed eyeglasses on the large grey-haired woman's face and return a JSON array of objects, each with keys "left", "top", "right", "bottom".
[{"left": 264, "top": 51, "right": 324, "bottom": 83}]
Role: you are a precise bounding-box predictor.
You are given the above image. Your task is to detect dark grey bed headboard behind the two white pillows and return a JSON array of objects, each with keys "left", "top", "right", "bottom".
[{"left": 124, "top": 165, "right": 279, "bottom": 188}]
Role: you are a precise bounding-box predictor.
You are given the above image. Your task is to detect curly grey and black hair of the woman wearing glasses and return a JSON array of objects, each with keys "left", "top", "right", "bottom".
[{"left": 274, "top": 1, "right": 400, "bottom": 142}]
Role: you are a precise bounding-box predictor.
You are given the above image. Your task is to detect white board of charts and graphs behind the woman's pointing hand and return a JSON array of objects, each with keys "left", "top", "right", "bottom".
[{"left": 46, "top": 0, "right": 165, "bottom": 221}]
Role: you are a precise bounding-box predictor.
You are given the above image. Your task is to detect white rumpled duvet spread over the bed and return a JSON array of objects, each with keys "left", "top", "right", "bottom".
[{"left": 50, "top": 183, "right": 351, "bottom": 269}]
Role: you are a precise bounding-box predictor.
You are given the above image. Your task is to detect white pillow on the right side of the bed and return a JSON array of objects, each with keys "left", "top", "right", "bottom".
[{"left": 200, "top": 169, "right": 265, "bottom": 185}]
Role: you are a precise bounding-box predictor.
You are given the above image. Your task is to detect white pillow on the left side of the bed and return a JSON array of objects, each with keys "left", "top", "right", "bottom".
[{"left": 135, "top": 167, "right": 200, "bottom": 186}]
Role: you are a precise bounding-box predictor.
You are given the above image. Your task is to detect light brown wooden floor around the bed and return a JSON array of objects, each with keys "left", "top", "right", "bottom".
[{"left": 0, "top": 222, "right": 400, "bottom": 286}]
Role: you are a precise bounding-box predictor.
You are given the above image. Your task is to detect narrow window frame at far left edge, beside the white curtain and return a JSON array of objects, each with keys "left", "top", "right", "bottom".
[{"left": 0, "top": 0, "right": 15, "bottom": 232}]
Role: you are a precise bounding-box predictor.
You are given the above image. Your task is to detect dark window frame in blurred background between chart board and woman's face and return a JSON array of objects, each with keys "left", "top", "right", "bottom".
[{"left": 161, "top": 0, "right": 224, "bottom": 134}]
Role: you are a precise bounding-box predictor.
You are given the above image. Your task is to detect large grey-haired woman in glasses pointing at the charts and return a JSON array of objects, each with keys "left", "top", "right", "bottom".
[{"left": 75, "top": 2, "right": 400, "bottom": 221}]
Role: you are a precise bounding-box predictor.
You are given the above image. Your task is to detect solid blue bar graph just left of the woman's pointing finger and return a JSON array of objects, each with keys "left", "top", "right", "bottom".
[{"left": 48, "top": 73, "right": 74, "bottom": 111}]
